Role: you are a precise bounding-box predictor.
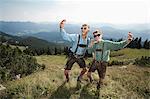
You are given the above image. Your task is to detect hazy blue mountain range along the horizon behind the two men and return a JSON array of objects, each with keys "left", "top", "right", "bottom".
[{"left": 0, "top": 21, "right": 150, "bottom": 42}]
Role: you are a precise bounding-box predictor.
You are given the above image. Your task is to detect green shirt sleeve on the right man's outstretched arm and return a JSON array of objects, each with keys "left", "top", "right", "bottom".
[{"left": 105, "top": 40, "right": 127, "bottom": 50}]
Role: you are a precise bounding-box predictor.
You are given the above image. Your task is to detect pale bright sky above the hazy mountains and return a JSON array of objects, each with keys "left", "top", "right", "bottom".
[{"left": 0, "top": 0, "right": 150, "bottom": 24}]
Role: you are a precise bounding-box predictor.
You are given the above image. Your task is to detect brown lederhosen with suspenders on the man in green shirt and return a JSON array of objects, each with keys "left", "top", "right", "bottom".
[{"left": 88, "top": 43, "right": 108, "bottom": 79}]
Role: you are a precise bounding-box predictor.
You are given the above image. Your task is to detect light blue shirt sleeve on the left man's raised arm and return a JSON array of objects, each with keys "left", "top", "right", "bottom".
[{"left": 60, "top": 29, "right": 77, "bottom": 42}]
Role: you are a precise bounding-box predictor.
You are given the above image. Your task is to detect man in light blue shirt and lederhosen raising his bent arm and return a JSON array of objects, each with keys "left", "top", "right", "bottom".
[{"left": 60, "top": 20, "right": 90, "bottom": 82}]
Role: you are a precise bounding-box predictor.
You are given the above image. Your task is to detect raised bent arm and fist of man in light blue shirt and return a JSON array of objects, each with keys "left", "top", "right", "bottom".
[{"left": 60, "top": 20, "right": 77, "bottom": 42}]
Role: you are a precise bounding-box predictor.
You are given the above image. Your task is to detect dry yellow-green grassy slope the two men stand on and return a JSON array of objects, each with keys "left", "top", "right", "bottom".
[{"left": 3, "top": 49, "right": 150, "bottom": 99}]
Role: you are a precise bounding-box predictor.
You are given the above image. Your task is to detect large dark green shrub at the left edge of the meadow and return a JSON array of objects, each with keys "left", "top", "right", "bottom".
[{"left": 0, "top": 45, "right": 44, "bottom": 82}]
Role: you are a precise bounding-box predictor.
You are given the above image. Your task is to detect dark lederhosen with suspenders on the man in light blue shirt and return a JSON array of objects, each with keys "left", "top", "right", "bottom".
[{"left": 65, "top": 35, "right": 88, "bottom": 70}]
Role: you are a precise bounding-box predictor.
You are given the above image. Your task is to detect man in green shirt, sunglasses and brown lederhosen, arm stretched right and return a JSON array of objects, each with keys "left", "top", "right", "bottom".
[{"left": 87, "top": 30, "right": 132, "bottom": 89}]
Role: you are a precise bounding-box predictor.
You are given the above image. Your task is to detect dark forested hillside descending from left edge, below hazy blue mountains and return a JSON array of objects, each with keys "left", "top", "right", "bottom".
[{"left": 0, "top": 31, "right": 65, "bottom": 48}]
